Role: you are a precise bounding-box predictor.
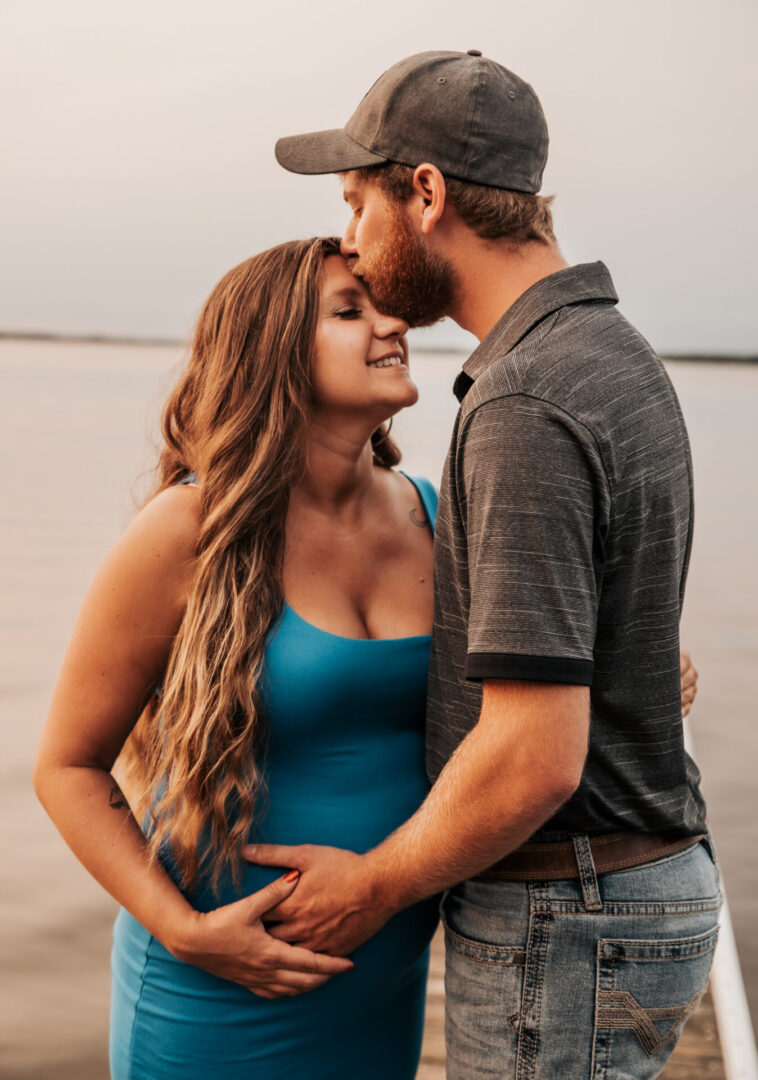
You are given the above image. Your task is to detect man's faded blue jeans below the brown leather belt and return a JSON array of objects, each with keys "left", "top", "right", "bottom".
[{"left": 442, "top": 838, "right": 721, "bottom": 1080}]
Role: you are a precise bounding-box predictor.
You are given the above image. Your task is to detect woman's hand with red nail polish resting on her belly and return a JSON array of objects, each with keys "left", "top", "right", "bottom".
[{"left": 171, "top": 872, "right": 354, "bottom": 998}]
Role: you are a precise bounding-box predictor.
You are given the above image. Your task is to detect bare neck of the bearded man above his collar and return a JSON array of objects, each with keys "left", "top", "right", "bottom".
[{"left": 448, "top": 237, "right": 568, "bottom": 341}]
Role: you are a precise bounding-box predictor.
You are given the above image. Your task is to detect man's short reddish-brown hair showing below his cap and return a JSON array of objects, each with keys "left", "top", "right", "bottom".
[{"left": 356, "top": 162, "right": 555, "bottom": 244}]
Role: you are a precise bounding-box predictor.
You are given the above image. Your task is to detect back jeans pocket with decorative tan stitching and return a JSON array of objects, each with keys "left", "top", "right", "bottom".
[{"left": 592, "top": 927, "right": 718, "bottom": 1080}]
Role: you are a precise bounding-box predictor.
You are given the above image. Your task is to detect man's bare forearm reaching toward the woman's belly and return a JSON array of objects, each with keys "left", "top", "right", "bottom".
[{"left": 366, "top": 688, "right": 586, "bottom": 908}]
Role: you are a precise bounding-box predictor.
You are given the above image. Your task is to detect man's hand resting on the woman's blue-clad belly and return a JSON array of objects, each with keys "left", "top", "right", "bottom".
[{"left": 242, "top": 843, "right": 397, "bottom": 956}]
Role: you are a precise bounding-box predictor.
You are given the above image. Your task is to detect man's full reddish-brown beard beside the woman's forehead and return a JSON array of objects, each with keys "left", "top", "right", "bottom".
[{"left": 352, "top": 198, "right": 457, "bottom": 326}]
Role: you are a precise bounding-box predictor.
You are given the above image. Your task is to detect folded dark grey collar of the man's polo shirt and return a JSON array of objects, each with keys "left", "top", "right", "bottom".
[{"left": 455, "top": 262, "right": 619, "bottom": 401}]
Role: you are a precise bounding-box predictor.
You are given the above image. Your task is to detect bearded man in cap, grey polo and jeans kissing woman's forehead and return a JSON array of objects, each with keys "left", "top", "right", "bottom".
[{"left": 247, "top": 50, "right": 719, "bottom": 1080}]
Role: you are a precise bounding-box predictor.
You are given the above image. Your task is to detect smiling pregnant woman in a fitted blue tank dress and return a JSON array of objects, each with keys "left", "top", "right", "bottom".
[{"left": 36, "top": 240, "right": 699, "bottom": 1080}]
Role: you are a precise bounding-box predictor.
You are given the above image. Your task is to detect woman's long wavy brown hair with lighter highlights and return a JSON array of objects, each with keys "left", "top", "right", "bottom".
[{"left": 119, "top": 239, "right": 400, "bottom": 890}]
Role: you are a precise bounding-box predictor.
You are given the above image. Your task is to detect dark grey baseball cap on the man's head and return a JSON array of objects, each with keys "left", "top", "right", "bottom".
[{"left": 275, "top": 49, "right": 547, "bottom": 193}]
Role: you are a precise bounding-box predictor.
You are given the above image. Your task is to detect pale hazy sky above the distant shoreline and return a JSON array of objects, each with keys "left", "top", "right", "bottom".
[{"left": 0, "top": 0, "right": 758, "bottom": 354}]
